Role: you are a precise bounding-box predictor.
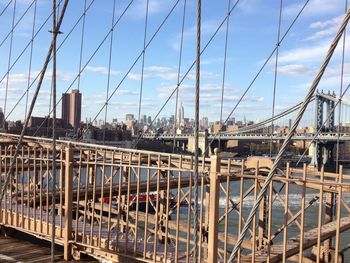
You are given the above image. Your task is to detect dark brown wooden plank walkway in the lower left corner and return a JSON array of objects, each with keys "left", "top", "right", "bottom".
[{"left": 0, "top": 234, "right": 98, "bottom": 263}]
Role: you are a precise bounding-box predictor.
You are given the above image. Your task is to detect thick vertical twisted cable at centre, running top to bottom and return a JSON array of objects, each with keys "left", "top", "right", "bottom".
[{"left": 193, "top": 0, "right": 202, "bottom": 263}]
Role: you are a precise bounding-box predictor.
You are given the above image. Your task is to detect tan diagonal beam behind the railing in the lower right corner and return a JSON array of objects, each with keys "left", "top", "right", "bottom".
[{"left": 250, "top": 217, "right": 350, "bottom": 262}]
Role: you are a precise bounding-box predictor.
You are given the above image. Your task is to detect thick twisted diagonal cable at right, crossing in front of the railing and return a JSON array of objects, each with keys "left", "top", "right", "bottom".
[{"left": 229, "top": 6, "right": 350, "bottom": 262}]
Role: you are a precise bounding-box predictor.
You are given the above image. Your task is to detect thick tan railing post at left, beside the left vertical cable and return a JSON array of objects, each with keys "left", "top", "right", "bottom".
[{"left": 64, "top": 146, "right": 73, "bottom": 260}]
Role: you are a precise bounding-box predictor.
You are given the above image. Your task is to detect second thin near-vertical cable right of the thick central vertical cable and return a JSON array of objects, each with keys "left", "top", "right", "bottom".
[{"left": 270, "top": 0, "right": 283, "bottom": 157}]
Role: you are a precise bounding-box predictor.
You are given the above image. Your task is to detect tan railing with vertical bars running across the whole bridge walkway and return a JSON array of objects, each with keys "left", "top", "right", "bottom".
[{"left": 0, "top": 140, "right": 350, "bottom": 262}]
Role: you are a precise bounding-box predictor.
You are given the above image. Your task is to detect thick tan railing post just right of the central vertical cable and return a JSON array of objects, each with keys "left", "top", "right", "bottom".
[{"left": 208, "top": 149, "right": 220, "bottom": 263}]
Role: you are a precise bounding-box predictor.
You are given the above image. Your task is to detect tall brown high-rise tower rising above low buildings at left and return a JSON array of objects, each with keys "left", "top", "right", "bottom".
[{"left": 62, "top": 89, "right": 81, "bottom": 129}]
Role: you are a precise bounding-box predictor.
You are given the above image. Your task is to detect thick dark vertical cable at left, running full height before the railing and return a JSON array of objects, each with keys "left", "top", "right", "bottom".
[{"left": 48, "top": 0, "right": 57, "bottom": 262}]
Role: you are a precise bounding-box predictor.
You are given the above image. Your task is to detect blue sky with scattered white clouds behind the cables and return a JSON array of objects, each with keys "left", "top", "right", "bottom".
[{"left": 0, "top": 0, "right": 350, "bottom": 128}]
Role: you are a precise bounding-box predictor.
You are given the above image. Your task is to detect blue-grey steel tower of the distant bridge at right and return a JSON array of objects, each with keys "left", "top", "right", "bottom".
[{"left": 310, "top": 91, "right": 336, "bottom": 172}]
